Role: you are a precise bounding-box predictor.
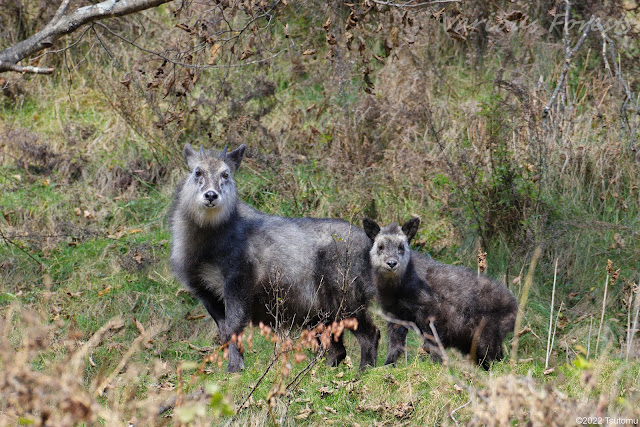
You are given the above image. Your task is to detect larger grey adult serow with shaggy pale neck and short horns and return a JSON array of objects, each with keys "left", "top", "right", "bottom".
[{"left": 170, "top": 144, "right": 380, "bottom": 372}]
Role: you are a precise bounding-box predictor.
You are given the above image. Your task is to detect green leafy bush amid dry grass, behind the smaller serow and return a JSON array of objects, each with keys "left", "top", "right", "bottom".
[{"left": 450, "top": 93, "right": 543, "bottom": 247}]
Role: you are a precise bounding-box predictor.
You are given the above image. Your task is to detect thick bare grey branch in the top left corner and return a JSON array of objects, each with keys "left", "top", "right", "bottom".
[{"left": 0, "top": 0, "right": 173, "bottom": 74}]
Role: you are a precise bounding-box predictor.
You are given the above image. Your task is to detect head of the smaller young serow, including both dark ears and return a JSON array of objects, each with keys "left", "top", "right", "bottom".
[{"left": 363, "top": 218, "right": 420, "bottom": 276}]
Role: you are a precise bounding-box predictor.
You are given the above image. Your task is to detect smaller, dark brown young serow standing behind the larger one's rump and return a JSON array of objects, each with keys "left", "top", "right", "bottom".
[{"left": 363, "top": 218, "right": 518, "bottom": 369}]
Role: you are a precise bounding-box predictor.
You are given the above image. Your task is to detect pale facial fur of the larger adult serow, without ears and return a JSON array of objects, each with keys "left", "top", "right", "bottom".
[{"left": 180, "top": 154, "right": 237, "bottom": 227}]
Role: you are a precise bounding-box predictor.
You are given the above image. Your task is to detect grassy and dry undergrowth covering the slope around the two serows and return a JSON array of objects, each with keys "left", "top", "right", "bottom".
[{"left": 0, "top": 2, "right": 640, "bottom": 425}]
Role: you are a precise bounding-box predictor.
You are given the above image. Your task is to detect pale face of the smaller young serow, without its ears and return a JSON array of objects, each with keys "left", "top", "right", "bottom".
[{"left": 369, "top": 229, "right": 410, "bottom": 277}]
